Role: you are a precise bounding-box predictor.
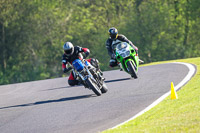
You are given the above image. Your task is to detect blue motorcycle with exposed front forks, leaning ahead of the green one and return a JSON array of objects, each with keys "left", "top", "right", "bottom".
[{"left": 72, "top": 59, "right": 108, "bottom": 96}]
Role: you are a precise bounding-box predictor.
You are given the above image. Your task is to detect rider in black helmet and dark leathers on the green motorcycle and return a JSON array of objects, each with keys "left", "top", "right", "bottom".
[{"left": 106, "top": 27, "right": 138, "bottom": 67}]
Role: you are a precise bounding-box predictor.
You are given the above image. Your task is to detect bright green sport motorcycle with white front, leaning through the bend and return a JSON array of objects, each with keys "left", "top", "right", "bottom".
[{"left": 115, "top": 42, "right": 139, "bottom": 79}]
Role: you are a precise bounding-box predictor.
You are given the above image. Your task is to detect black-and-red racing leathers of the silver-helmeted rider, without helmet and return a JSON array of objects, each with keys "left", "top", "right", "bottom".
[{"left": 62, "top": 46, "right": 92, "bottom": 86}]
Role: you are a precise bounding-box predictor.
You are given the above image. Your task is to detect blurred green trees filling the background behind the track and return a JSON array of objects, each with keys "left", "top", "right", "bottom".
[{"left": 0, "top": 0, "right": 200, "bottom": 85}]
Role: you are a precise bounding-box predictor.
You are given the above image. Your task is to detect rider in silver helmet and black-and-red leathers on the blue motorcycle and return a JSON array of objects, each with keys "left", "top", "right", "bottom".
[{"left": 62, "top": 42, "right": 98, "bottom": 86}]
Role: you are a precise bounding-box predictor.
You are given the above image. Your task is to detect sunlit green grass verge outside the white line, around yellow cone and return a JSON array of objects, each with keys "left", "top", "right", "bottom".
[{"left": 103, "top": 57, "right": 200, "bottom": 133}]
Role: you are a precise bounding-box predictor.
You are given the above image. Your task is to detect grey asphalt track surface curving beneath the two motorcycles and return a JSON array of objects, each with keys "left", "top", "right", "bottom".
[{"left": 0, "top": 63, "right": 195, "bottom": 133}]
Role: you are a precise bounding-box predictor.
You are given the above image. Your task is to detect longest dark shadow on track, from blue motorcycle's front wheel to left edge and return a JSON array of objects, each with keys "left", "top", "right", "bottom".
[{"left": 0, "top": 94, "right": 96, "bottom": 109}]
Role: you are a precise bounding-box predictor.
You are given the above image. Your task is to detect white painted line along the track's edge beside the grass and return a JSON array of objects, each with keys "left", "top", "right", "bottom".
[{"left": 111, "top": 62, "right": 195, "bottom": 129}]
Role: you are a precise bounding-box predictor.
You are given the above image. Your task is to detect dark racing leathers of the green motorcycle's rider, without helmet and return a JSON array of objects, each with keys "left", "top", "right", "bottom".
[{"left": 106, "top": 34, "right": 138, "bottom": 67}]
